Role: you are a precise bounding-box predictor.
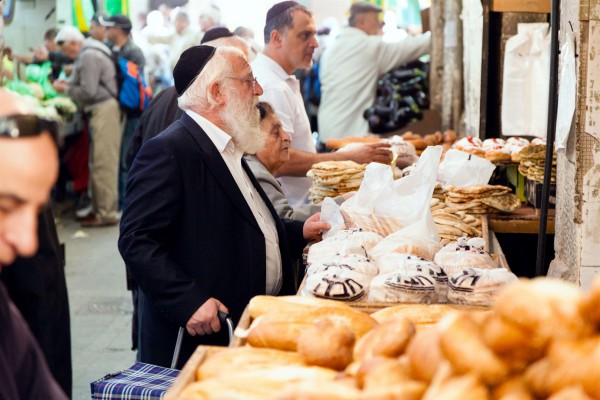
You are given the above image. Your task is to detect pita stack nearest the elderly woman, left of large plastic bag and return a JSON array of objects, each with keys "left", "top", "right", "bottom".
[{"left": 306, "top": 161, "right": 366, "bottom": 204}]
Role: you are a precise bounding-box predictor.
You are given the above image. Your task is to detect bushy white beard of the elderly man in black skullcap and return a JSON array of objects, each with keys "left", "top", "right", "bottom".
[{"left": 221, "top": 92, "right": 265, "bottom": 154}]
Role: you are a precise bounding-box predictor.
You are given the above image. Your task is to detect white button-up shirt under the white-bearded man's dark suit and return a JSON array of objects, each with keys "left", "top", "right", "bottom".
[{"left": 186, "top": 110, "right": 282, "bottom": 295}]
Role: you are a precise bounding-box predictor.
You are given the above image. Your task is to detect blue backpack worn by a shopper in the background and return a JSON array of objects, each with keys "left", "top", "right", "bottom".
[{"left": 112, "top": 52, "right": 152, "bottom": 113}]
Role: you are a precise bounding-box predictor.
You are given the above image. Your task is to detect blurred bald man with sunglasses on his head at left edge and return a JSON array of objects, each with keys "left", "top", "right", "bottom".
[{"left": 0, "top": 89, "right": 68, "bottom": 400}]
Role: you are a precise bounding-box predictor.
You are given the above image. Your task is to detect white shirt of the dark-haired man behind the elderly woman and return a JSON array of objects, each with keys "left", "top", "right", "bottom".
[{"left": 250, "top": 54, "right": 317, "bottom": 207}]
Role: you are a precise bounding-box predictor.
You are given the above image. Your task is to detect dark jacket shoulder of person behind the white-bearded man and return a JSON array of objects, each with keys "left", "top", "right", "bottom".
[{"left": 125, "top": 86, "right": 183, "bottom": 167}]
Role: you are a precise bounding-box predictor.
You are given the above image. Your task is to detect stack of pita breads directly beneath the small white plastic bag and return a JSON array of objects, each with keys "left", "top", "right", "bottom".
[{"left": 446, "top": 185, "right": 521, "bottom": 214}]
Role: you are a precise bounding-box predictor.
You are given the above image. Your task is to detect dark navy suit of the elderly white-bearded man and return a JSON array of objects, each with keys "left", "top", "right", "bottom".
[{"left": 119, "top": 114, "right": 305, "bottom": 366}]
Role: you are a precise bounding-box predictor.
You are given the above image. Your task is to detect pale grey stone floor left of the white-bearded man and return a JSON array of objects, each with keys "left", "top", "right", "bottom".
[{"left": 56, "top": 208, "right": 135, "bottom": 400}]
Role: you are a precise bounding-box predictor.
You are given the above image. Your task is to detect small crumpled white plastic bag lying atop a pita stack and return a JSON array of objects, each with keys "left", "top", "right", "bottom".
[{"left": 438, "top": 149, "right": 496, "bottom": 188}]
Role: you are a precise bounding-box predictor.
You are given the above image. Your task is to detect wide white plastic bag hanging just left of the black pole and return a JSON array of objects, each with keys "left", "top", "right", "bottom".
[{"left": 502, "top": 23, "right": 550, "bottom": 137}]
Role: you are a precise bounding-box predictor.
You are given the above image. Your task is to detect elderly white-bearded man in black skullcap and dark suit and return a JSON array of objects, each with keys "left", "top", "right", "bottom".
[{"left": 119, "top": 46, "right": 329, "bottom": 367}]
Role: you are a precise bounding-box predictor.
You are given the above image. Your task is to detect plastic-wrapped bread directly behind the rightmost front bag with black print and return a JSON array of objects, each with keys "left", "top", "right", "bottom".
[{"left": 433, "top": 236, "right": 499, "bottom": 277}]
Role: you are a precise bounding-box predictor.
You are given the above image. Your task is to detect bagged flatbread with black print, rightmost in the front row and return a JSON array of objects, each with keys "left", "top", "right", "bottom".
[{"left": 448, "top": 268, "right": 518, "bottom": 306}]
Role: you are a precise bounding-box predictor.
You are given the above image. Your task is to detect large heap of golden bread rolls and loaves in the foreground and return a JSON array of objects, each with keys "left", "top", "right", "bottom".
[{"left": 172, "top": 278, "right": 600, "bottom": 400}]
